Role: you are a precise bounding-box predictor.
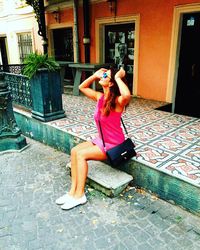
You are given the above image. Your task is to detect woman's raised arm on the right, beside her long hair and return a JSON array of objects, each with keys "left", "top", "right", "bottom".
[{"left": 115, "top": 68, "right": 131, "bottom": 106}]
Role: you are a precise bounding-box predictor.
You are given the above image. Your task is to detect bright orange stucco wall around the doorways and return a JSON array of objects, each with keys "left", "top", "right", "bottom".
[{"left": 46, "top": 0, "right": 200, "bottom": 101}]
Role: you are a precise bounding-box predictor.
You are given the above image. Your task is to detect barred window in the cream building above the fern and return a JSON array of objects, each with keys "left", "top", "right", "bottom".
[{"left": 18, "top": 33, "right": 33, "bottom": 63}]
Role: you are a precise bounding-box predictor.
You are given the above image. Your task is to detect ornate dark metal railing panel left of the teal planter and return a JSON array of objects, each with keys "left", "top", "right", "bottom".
[{"left": 5, "top": 73, "right": 32, "bottom": 110}]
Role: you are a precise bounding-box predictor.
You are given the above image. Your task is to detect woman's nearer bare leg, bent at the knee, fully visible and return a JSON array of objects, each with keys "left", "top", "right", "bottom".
[{"left": 73, "top": 142, "right": 107, "bottom": 198}]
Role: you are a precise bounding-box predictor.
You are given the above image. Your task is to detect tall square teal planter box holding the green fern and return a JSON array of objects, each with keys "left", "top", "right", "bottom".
[{"left": 31, "top": 69, "right": 66, "bottom": 122}]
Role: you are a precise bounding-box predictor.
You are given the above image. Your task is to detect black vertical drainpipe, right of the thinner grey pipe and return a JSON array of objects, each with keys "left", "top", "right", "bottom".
[{"left": 83, "top": 0, "right": 90, "bottom": 63}]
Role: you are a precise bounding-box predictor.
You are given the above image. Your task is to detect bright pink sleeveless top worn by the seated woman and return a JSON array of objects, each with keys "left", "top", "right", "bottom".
[{"left": 92, "top": 95, "right": 125, "bottom": 152}]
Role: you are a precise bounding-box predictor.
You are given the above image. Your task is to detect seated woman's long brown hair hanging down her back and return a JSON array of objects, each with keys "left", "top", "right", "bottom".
[{"left": 103, "top": 68, "right": 126, "bottom": 116}]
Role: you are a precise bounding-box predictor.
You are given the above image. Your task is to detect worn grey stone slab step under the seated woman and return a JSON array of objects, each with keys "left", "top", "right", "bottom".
[{"left": 67, "top": 161, "right": 133, "bottom": 197}]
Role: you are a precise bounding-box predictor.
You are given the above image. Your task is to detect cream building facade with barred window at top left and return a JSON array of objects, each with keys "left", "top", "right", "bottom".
[{"left": 0, "top": 0, "right": 42, "bottom": 65}]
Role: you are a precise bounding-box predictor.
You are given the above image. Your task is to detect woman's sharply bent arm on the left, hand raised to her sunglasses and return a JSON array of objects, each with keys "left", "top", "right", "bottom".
[{"left": 79, "top": 69, "right": 105, "bottom": 101}]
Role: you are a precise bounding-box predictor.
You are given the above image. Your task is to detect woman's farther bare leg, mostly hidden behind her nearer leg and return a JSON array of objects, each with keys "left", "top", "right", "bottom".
[{"left": 69, "top": 142, "right": 96, "bottom": 196}]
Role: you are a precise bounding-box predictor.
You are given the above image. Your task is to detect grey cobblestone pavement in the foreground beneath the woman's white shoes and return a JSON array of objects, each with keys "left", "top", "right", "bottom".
[{"left": 0, "top": 139, "right": 200, "bottom": 250}]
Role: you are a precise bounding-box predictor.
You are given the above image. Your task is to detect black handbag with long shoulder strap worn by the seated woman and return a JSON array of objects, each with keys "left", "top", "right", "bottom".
[{"left": 99, "top": 118, "right": 136, "bottom": 167}]
